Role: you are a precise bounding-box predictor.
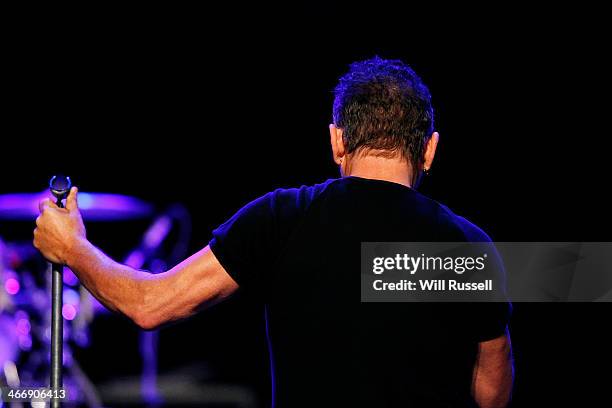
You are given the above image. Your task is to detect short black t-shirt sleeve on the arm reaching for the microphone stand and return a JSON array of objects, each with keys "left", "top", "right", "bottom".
[{"left": 209, "top": 189, "right": 300, "bottom": 290}]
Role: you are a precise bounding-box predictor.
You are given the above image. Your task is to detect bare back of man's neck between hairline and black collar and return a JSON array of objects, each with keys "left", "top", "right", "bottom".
[{"left": 343, "top": 154, "right": 412, "bottom": 187}]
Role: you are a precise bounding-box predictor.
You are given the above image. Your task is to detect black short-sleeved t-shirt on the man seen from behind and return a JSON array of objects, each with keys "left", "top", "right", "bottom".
[{"left": 210, "top": 177, "right": 510, "bottom": 408}]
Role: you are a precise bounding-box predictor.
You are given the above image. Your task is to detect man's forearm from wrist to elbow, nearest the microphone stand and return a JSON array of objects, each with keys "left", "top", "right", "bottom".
[{"left": 66, "top": 240, "right": 154, "bottom": 325}]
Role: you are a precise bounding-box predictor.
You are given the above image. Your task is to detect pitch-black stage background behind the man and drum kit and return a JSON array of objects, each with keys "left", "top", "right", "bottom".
[{"left": 0, "top": 3, "right": 612, "bottom": 407}]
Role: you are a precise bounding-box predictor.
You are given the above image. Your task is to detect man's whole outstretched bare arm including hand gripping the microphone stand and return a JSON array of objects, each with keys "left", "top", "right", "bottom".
[{"left": 34, "top": 189, "right": 238, "bottom": 329}]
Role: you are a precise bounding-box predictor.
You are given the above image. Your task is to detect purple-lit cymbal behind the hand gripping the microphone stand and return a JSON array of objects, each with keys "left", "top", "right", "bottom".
[{"left": 0, "top": 191, "right": 154, "bottom": 221}]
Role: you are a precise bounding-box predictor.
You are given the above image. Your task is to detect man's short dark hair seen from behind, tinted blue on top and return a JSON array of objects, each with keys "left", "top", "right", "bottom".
[{"left": 333, "top": 57, "right": 434, "bottom": 172}]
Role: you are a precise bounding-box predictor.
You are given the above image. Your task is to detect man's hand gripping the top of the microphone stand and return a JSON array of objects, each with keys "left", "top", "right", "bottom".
[{"left": 34, "top": 187, "right": 85, "bottom": 264}]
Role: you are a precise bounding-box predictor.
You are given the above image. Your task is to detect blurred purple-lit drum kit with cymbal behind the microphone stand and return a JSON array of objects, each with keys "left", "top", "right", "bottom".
[{"left": 0, "top": 183, "right": 191, "bottom": 407}]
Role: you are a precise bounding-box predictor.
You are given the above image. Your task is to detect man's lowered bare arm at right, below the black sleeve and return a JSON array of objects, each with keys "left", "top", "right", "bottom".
[{"left": 472, "top": 330, "right": 514, "bottom": 408}]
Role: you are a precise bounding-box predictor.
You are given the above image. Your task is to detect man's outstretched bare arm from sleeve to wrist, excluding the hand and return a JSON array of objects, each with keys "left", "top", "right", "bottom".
[{"left": 68, "top": 241, "right": 238, "bottom": 329}]
